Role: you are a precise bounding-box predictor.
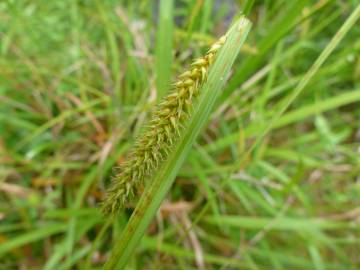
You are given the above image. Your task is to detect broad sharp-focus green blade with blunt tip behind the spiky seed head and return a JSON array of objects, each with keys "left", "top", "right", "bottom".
[{"left": 105, "top": 17, "right": 251, "bottom": 269}]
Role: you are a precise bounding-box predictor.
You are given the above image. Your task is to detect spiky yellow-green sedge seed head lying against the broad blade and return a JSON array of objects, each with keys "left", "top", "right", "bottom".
[{"left": 102, "top": 36, "right": 226, "bottom": 213}]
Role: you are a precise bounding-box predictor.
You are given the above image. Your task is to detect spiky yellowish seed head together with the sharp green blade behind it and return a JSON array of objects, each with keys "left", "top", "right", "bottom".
[{"left": 103, "top": 17, "right": 251, "bottom": 269}]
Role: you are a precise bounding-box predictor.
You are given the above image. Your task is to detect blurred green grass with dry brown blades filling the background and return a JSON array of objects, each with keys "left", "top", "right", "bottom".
[{"left": 0, "top": 0, "right": 360, "bottom": 270}]
